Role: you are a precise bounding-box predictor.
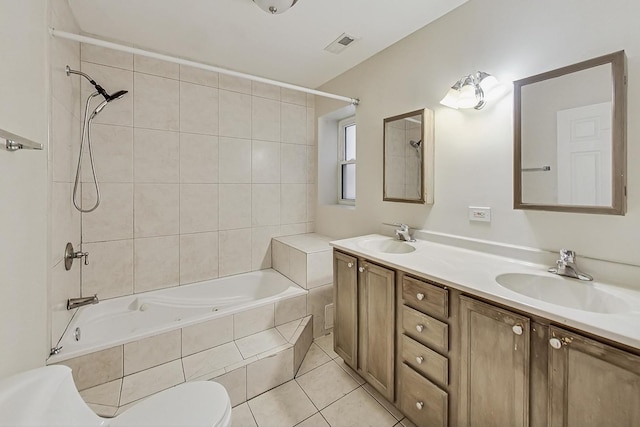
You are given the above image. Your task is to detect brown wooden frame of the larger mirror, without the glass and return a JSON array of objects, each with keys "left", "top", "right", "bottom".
[{"left": 513, "top": 50, "right": 627, "bottom": 215}]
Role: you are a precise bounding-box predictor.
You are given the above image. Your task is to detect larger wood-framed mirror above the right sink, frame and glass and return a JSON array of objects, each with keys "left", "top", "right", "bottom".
[{"left": 513, "top": 51, "right": 627, "bottom": 215}]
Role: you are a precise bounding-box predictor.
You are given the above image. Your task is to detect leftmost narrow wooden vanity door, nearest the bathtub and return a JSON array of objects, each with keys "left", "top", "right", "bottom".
[{"left": 333, "top": 252, "right": 358, "bottom": 369}]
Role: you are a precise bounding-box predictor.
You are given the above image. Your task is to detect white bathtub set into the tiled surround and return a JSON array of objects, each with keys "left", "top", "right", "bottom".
[{"left": 47, "top": 269, "right": 307, "bottom": 364}]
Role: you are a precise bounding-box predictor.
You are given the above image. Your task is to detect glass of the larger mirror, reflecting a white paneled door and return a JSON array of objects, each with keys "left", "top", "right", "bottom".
[{"left": 521, "top": 64, "right": 612, "bottom": 206}]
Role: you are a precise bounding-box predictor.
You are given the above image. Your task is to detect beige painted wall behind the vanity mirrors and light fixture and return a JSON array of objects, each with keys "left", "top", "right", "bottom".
[{"left": 316, "top": 0, "right": 640, "bottom": 265}]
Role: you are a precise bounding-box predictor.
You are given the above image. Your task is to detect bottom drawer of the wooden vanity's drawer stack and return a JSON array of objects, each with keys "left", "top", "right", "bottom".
[{"left": 400, "top": 363, "right": 449, "bottom": 427}]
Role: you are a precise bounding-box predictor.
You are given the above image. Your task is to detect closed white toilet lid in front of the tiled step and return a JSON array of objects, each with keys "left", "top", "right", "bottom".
[{"left": 105, "top": 381, "right": 231, "bottom": 427}]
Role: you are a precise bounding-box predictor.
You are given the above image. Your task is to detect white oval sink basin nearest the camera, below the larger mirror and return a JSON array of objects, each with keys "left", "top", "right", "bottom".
[{"left": 496, "top": 273, "right": 631, "bottom": 314}]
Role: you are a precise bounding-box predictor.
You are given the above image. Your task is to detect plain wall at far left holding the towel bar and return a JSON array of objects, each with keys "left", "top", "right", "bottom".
[{"left": 0, "top": 0, "right": 49, "bottom": 377}]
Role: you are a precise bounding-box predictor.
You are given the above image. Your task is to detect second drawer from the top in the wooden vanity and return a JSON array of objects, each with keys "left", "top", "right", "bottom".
[{"left": 402, "top": 305, "right": 449, "bottom": 352}]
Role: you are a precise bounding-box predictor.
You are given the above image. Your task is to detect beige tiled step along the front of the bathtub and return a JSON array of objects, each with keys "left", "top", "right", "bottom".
[{"left": 60, "top": 316, "right": 313, "bottom": 417}]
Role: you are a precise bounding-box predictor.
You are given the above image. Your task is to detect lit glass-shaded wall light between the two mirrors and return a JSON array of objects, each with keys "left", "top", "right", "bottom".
[{"left": 440, "top": 71, "right": 504, "bottom": 110}]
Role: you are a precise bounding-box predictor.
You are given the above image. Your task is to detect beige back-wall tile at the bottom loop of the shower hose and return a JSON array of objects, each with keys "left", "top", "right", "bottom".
[{"left": 82, "top": 183, "right": 133, "bottom": 242}]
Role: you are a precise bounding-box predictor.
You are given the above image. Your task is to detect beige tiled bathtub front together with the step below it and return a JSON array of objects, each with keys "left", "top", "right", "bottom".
[{"left": 51, "top": 305, "right": 313, "bottom": 416}]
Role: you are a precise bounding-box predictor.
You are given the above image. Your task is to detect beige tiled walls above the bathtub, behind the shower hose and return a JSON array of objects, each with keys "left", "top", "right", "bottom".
[{"left": 50, "top": 40, "right": 317, "bottom": 344}]
